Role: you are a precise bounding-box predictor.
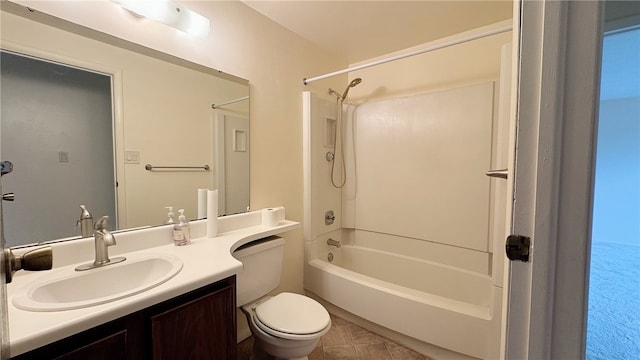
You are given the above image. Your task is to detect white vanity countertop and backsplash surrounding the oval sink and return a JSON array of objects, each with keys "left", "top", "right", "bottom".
[{"left": 7, "top": 208, "right": 300, "bottom": 356}]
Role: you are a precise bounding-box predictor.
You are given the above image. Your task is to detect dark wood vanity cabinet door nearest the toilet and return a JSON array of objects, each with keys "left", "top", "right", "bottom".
[{"left": 151, "top": 285, "right": 236, "bottom": 360}]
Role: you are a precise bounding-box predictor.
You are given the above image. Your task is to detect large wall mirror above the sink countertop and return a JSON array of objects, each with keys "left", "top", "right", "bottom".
[{"left": 0, "top": 3, "right": 249, "bottom": 247}]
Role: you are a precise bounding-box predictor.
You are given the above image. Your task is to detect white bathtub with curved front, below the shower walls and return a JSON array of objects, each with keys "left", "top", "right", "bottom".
[{"left": 305, "top": 240, "right": 502, "bottom": 359}]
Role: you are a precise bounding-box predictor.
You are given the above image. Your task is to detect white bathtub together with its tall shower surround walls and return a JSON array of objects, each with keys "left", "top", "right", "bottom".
[{"left": 303, "top": 54, "right": 508, "bottom": 359}]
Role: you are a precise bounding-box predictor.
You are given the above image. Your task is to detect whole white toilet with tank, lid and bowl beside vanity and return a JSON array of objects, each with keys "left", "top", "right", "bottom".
[{"left": 233, "top": 236, "right": 331, "bottom": 360}]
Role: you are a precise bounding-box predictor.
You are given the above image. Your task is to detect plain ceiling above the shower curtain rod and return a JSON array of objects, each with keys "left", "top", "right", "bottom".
[{"left": 244, "top": 0, "right": 512, "bottom": 64}]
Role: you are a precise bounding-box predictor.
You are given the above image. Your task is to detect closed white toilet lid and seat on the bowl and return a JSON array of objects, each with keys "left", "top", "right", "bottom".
[{"left": 252, "top": 292, "right": 331, "bottom": 340}]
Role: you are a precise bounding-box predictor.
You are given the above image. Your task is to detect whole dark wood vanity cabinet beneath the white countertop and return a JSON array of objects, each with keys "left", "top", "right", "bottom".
[{"left": 13, "top": 276, "right": 236, "bottom": 360}]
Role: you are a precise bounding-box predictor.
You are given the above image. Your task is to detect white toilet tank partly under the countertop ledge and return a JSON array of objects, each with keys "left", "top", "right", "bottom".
[{"left": 233, "top": 236, "right": 284, "bottom": 307}]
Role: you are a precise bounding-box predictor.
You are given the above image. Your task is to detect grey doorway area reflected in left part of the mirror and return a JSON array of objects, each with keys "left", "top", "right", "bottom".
[{"left": 0, "top": 51, "right": 116, "bottom": 244}]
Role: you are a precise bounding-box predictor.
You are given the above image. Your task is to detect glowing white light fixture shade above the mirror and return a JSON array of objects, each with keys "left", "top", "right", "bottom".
[{"left": 113, "top": 0, "right": 210, "bottom": 37}]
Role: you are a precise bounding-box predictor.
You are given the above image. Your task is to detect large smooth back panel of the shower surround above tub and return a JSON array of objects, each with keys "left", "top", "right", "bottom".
[{"left": 354, "top": 82, "right": 494, "bottom": 252}]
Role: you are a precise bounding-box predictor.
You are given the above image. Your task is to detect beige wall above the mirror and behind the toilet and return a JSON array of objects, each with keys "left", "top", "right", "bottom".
[{"left": 2, "top": 1, "right": 346, "bottom": 292}]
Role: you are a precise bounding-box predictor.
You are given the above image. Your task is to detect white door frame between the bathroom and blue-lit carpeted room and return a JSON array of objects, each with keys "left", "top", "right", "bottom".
[{"left": 504, "top": 1, "right": 603, "bottom": 359}]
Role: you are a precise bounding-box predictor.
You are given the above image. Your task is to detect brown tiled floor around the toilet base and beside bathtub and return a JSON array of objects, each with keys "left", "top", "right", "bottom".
[{"left": 238, "top": 315, "right": 429, "bottom": 360}]
